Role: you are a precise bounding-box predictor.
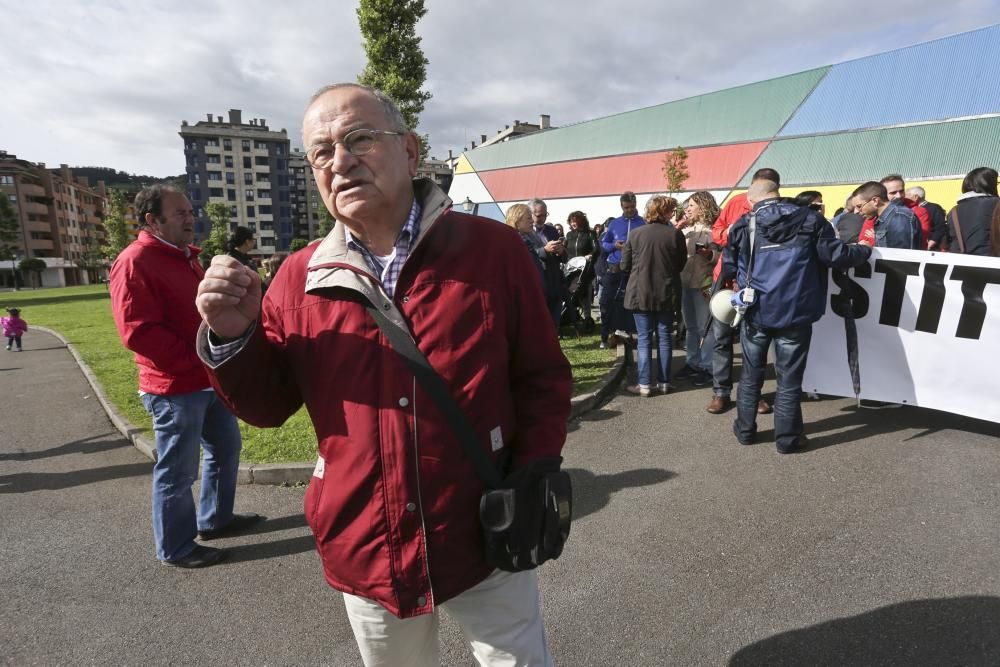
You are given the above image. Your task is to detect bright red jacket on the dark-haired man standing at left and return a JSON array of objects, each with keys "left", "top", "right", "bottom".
[{"left": 110, "top": 230, "right": 209, "bottom": 395}]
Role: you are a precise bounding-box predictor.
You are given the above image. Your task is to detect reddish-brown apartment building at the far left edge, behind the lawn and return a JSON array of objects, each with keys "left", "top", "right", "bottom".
[{"left": 0, "top": 151, "right": 108, "bottom": 287}]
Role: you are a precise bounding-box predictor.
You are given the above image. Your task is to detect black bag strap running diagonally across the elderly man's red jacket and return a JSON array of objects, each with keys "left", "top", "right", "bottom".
[{"left": 365, "top": 304, "right": 502, "bottom": 489}]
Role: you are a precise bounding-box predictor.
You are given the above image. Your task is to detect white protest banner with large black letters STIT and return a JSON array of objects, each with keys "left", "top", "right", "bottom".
[{"left": 802, "top": 248, "right": 1000, "bottom": 422}]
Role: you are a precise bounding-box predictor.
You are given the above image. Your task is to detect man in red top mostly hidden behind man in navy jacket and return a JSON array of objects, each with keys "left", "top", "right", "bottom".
[{"left": 705, "top": 167, "right": 781, "bottom": 415}]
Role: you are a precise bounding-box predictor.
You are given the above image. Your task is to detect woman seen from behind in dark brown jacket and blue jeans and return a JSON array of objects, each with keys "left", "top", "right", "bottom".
[{"left": 621, "top": 195, "right": 687, "bottom": 396}]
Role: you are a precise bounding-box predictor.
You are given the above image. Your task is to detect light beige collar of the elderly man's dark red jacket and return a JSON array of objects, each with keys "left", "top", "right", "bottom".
[{"left": 305, "top": 178, "right": 451, "bottom": 305}]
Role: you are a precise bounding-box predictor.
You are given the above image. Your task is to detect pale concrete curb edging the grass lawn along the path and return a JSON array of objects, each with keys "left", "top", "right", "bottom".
[{"left": 43, "top": 325, "right": 628, "bottom": 485}]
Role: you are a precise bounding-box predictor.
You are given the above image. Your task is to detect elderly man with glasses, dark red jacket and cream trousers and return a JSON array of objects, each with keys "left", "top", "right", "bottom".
[{"left": 198, "top": 84, "right": 572, "bottom": 665}]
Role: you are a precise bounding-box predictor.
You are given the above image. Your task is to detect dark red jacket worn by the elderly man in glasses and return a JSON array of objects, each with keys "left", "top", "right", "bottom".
[{"left": 199, "top": 179, "right": 572, "bottom": 618}]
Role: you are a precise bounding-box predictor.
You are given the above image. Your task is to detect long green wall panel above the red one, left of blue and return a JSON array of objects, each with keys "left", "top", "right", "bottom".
[{"left": 465, "top": 67, "right": 829, "bottom": 171}]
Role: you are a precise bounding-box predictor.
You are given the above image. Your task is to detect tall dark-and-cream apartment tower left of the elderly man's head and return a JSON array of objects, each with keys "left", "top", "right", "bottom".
[{"left": 180, "top": 109, "right": 295, "bottom": 257}]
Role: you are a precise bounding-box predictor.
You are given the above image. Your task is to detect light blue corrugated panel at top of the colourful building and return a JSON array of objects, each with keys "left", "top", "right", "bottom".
[{"left": 778, "top": 25, "right": 1000, "bottom": 136}]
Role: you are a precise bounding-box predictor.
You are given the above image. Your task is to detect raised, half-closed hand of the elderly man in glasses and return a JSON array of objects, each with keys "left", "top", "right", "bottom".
[{"left": 195, "top": 255, "right": 260, "bottom": 340}]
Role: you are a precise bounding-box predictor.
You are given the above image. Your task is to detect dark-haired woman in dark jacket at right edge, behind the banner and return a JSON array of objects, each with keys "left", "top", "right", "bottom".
[{"left": 946, "top": 167, "right": 1000, "bottom": 257}]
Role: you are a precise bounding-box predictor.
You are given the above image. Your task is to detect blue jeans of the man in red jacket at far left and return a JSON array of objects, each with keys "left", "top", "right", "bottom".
[{"left": 142, "top": 391, "right": 242, "bottom": 560}]
